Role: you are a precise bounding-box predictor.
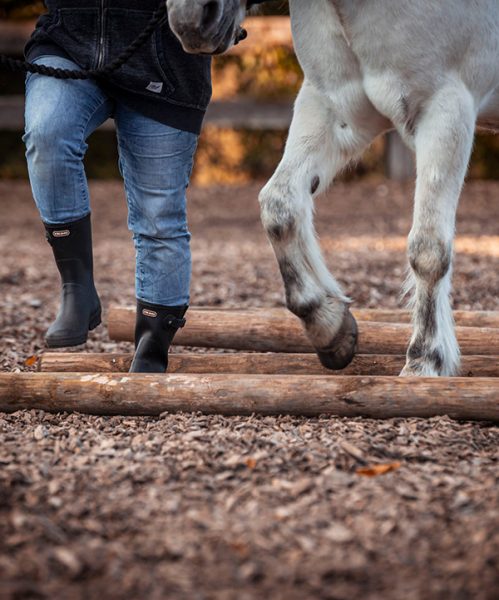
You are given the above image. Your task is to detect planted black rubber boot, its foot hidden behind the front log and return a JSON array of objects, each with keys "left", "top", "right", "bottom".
[{"left": 130, "top": 300, "right": 188, "bottom": 373}]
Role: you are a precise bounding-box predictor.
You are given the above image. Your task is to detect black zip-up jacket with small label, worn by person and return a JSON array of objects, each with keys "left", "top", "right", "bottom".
[{"left": 25, "top": 0, "right": 211, "bottom": 133}]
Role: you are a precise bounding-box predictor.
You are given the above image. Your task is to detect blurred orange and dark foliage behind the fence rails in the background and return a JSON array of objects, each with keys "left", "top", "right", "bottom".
[{"left": 0, "top": 0, "right": 499, "bottom": 184}]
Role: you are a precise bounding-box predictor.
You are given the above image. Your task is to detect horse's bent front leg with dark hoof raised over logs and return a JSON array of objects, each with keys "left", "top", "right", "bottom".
[{"left": 259, "top": 82, "right": 386, "bottom": 369}]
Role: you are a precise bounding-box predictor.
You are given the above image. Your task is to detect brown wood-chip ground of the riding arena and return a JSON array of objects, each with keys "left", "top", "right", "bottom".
[{"left": 0, "top": 181, "right": 499, "bottom": 600}]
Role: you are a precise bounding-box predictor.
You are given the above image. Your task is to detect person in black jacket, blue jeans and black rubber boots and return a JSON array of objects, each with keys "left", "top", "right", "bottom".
[{"left": 23, "top": 0, "right": 211, "bottom": 372}]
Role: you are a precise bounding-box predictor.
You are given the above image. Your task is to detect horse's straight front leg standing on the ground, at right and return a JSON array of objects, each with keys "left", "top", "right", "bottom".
[{"left": 402, "top": 82, "right": 476, "bottom": 376}]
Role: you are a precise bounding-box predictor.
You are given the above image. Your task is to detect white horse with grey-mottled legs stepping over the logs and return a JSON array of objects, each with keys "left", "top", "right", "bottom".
[{"left": 167, "top": 0, "right": 499, "bottom": 376}]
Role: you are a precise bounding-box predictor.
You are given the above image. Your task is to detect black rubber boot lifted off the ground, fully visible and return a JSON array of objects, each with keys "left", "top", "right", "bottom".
[{"left": 45, "top": 215, "right": 101, "bottom": 348}]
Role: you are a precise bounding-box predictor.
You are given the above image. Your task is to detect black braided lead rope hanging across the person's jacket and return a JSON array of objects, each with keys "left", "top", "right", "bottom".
[{"left": 0, "top": 2, "right": 167, "bottom": 79}]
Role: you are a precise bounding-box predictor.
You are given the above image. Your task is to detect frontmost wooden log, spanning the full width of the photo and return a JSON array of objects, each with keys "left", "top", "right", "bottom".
[{"left": 0, "top": 373, "right": 499, "bottom": 421}]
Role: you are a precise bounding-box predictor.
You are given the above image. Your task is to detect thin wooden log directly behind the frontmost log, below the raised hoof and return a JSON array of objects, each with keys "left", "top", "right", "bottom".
[{"left": 39, "top": 352, "right": 499, "bottom": 377}]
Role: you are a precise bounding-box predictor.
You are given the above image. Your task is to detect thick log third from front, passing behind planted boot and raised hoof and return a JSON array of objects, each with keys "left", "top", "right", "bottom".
[{"left": 108, "top": 307, "right": 499, "bottom": 356}]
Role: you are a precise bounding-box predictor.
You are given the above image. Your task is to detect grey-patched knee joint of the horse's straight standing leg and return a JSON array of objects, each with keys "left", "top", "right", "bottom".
[{"left": 408, "top": 235, "right": 452, "bottom": 283}]
